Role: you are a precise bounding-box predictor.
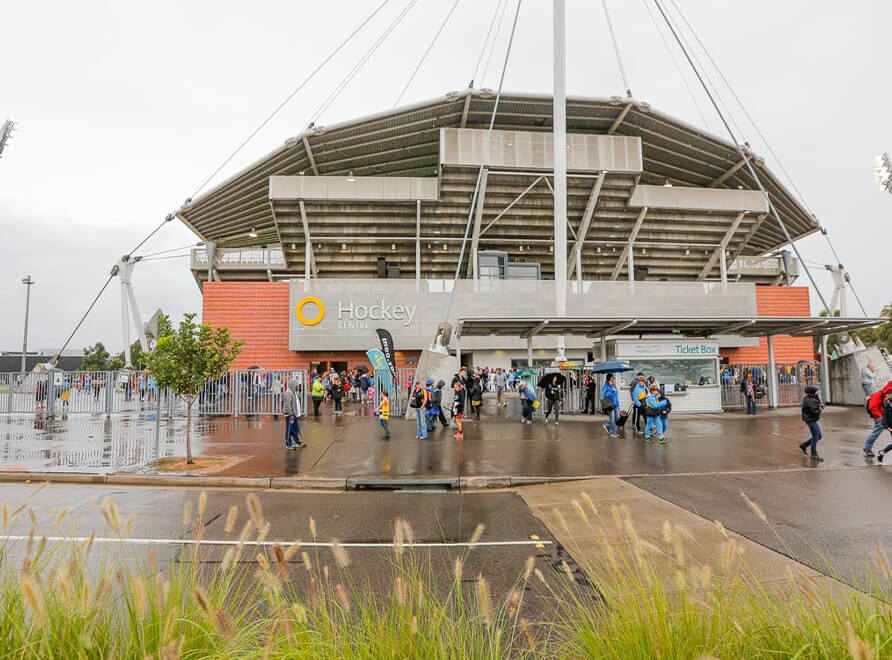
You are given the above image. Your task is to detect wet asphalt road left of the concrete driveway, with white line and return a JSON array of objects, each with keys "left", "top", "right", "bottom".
[{"left": 0, "top": 484, "right": 558, "bottom": 612}]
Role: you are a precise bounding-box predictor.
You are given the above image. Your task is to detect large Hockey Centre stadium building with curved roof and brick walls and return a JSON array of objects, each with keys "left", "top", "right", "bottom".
[{"left": 178, "top": 89, "right": 865, "bottom": 410}]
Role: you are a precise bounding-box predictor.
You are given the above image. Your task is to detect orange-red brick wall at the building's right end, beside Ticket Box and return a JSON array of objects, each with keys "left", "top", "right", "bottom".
[{"left": 719, "top": 286, "right": 815, "bottom": 364}]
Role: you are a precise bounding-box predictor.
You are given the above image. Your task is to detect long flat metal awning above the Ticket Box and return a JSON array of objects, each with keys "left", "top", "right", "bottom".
[{"left": 457, "top": 316, "right": 888, "bottom": 338}]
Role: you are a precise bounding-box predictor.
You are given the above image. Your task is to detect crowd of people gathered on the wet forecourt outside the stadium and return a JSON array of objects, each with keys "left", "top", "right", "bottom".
[{"left": 283, "top": 365, "right": 892, "bottom": 462}]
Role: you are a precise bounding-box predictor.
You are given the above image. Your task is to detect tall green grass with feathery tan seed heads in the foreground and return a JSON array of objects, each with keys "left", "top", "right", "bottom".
[{"left": 0, "top": 494, "right": 892, "bottom": 660}]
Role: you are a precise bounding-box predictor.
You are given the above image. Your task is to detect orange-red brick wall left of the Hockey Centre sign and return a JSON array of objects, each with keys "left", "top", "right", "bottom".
[{"left": 202, "top": 282, "right": 419, "bottom": 369}]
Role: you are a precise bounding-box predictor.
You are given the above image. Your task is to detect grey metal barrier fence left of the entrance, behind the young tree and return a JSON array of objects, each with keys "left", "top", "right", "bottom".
[{"left": 0, "top": 370, "right": 308, "bottom": 417}]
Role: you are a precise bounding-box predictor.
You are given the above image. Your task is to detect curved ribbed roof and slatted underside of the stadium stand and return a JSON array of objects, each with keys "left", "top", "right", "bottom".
[{"left": 178, "top": 90, "right": 819, "bottom": 276}]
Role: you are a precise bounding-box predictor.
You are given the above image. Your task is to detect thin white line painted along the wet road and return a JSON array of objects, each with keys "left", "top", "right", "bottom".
[{"left": 0, "top": 534, "right": 552, "bottom": 548}]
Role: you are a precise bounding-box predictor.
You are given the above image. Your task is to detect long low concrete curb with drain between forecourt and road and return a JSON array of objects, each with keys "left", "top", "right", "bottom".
[{"left": 0, "top": 472, "right": 616, "bottom": 491}]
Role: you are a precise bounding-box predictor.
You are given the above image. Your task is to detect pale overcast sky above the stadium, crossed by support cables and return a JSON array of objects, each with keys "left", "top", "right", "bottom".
[{"left": 0, "top": 0, "right": 892, "bottom": 350}]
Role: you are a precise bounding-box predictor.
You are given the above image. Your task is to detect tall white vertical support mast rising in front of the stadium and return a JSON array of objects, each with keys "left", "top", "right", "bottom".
[{"left": 552, "top": 0, "right": 568, "bottom": 362}]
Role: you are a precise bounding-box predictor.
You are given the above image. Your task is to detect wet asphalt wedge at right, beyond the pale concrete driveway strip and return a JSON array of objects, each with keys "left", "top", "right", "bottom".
[{"left": 627, "top": 466, "right": 892, "bottom": 586}]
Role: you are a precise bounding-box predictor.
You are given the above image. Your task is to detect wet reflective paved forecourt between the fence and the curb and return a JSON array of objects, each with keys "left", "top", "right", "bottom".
[{"left": 0, "top": 401, "right": 882, "bottom": 479}]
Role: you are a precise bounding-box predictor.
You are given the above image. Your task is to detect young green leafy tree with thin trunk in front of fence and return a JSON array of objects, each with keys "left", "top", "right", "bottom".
[{"left": 146, "top": 314, "right": 244, "bottom": 465}]
